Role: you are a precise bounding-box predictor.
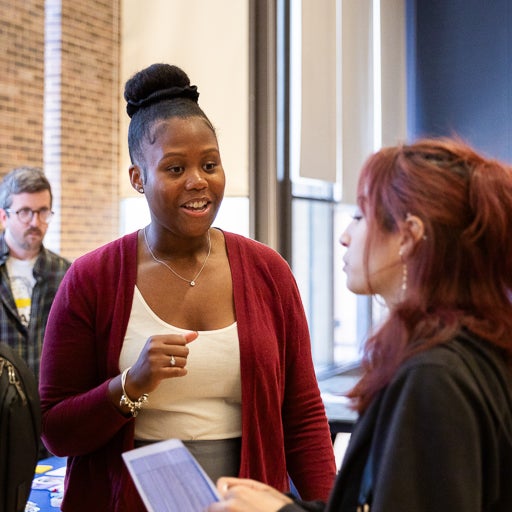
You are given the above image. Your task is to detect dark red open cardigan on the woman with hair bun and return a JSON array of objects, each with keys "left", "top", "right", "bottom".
[{"left": 40, "top": 233, "right": 335, "bottom": 512}]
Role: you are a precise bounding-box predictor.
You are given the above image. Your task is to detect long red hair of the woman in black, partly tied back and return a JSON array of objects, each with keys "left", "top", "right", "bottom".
[{"left": 349, "top": 138, "right": 512, "bottom": 412}]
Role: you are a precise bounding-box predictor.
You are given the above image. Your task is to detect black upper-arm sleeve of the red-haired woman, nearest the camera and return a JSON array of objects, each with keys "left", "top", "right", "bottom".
[{"left": 372, "top": 364, "right": 490, "bottom": 512}]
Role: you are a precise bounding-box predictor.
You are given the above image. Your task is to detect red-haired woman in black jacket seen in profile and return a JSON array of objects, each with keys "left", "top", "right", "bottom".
[{"left": 208, "top": 139, "right": 512, "bottom": 512}]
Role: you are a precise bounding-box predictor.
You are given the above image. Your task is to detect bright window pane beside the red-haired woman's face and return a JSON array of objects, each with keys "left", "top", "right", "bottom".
[{"left": 292, "top": 198, "right": 362, "bottom": 370}]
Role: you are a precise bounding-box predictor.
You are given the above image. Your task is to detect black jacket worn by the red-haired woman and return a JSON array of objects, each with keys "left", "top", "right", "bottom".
[{"left": 282, "top": 334, "right": 512, "bottom": 512}]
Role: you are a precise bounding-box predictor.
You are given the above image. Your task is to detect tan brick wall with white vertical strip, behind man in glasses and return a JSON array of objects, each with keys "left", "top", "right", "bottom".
[{"left": 0, "top": 0, "right": 121, "bottom": 259}]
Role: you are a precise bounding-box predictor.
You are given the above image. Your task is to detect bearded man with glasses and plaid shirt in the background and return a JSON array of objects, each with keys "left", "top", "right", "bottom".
[{"left": 0, "top": 167, "right": 70, "bottom": 380}]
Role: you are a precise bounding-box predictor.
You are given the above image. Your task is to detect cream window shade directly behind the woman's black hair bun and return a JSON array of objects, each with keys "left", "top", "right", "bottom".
[{"left": 119, "top": 0, "right": 249, "bottom": 197}]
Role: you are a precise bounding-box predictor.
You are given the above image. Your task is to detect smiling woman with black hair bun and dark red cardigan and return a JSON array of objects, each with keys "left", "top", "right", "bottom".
[{"left": 41, "top": 64, "right": 335, "bottom": 512}]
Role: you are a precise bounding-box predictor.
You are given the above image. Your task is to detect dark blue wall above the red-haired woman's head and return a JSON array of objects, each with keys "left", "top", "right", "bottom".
[{"left": 406, "top": 0, "right": 512, "bottom": 162}]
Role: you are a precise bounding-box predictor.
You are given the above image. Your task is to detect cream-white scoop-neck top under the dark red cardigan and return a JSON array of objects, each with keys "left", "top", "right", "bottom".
[{"left": 119, "top": 287, "right": 242, "bottom": 441}]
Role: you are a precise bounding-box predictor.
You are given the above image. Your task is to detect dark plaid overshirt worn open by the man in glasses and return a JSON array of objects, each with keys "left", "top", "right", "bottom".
[{"left": 0, "top": 233, "right": 71, "bottom": 381}]
